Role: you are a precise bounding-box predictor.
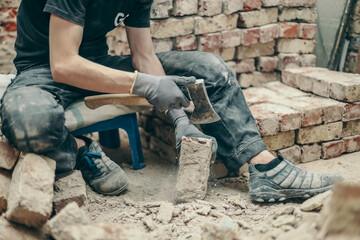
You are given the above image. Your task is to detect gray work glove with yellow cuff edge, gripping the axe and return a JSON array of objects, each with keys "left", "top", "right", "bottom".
[{"left": 132, "top": 73, "right": 196, "bottom": 112}]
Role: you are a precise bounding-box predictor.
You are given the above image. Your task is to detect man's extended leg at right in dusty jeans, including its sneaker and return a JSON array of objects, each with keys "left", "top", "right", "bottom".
[{"left": 158, "top": 52, "right": 342, "bottom": 202}]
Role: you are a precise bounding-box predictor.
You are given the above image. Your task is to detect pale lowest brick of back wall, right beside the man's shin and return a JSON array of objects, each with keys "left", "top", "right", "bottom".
[{"left": 239, "top": 72, "right": 280, "bottom": 88}]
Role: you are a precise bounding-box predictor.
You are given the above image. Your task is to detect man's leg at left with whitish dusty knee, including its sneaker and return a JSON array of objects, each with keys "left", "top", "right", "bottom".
[{"left": 1, "top": 68, "right": 127, "bottom": 195}]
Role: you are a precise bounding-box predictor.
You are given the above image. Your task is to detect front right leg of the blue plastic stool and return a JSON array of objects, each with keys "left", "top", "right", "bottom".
[{"left": 124, "top": 113, "right": 146, "bottom": 169}]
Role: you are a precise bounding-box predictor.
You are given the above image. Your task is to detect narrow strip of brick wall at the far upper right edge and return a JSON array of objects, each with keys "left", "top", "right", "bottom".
[{"left": 344, "top": 0, "right": 360, "bottom": 73}]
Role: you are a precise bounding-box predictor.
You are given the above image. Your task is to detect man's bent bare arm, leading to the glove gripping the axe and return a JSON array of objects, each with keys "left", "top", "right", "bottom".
[{"left": 49, "top": 14, "right": 135, "bottom": 93}]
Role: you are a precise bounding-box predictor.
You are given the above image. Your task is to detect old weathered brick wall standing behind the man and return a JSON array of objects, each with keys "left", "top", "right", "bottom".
[{"left": 0, "top": 0, "right": 316, "bottom": 81}]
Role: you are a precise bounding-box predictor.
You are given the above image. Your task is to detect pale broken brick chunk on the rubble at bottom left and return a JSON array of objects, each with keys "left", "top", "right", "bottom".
[{"left": 46, "top": 202, "right": 89, "bottom": 239}]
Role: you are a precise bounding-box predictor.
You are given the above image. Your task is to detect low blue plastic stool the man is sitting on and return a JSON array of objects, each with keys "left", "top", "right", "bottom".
[{"left": 72, "top": 113, "right": 146, "bottom": 169}]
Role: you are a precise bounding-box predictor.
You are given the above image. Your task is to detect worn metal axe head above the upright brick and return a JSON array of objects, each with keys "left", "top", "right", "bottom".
[{"left": 182, "top": 79, "right": 220, "bottom": 124}]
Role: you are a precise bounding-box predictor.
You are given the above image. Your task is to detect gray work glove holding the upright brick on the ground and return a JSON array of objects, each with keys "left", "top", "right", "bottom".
[{"left": 167, "top": 109, "right": 218, "bottom": 161}]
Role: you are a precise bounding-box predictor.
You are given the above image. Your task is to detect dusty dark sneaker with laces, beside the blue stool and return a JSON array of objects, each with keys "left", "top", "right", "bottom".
[{"left": 76, "top": 136, "right": 128, "bottom": 195}]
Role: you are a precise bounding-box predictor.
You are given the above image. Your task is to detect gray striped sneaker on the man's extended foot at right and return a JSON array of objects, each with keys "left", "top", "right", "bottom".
[{"left": 249, "top": 155, "right": 344, "bottom": 202}]
